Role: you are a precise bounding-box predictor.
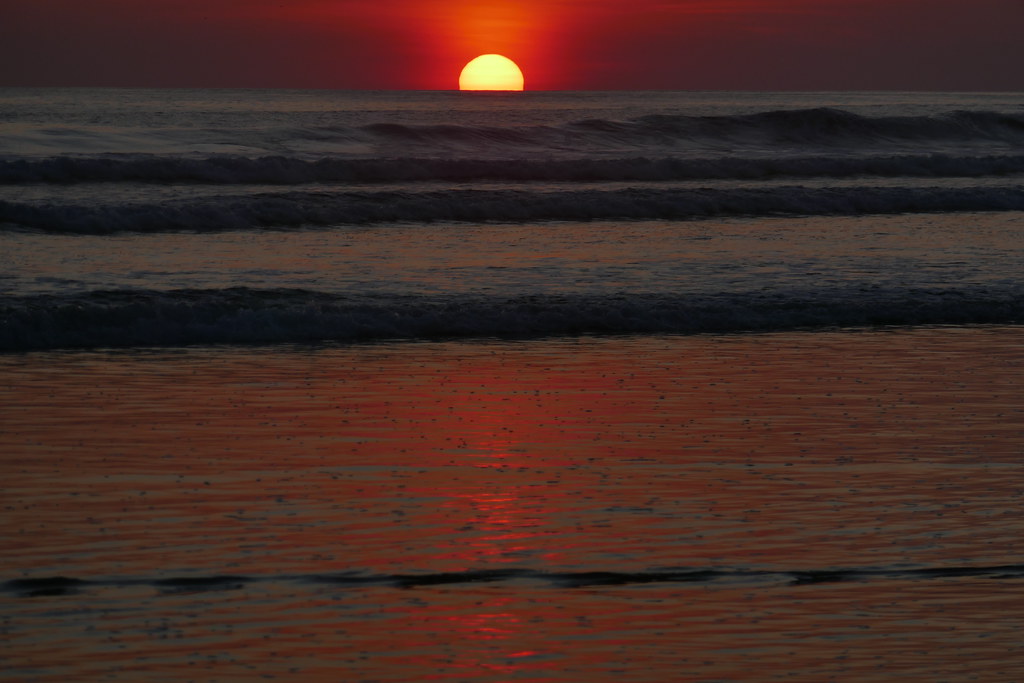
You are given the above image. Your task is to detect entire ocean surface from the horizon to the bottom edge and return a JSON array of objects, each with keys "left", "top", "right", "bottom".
[{"left": 0, "top": 88, "right": 1024, "bottom": 682}]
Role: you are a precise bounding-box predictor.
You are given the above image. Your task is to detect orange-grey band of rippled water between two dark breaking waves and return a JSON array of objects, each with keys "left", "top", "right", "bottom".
[{"left": 0, "top": 212, "right": 1024, "bottom": 298}]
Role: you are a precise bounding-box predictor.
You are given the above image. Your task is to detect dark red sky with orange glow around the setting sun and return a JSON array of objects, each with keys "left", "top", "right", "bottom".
[{"left": 0, "top": 0, "right": 1024, "bottom": 90}]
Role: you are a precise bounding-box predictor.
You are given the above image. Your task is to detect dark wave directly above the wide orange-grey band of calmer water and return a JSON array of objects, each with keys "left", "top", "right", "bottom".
[{"left": 0, "top": 185, "right": 1024, "bottom": 234}]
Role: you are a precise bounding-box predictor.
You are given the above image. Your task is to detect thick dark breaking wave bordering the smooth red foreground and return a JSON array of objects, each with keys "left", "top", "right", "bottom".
[{"left": 0, "top": 288, "right": 1024, "bottom": 352}]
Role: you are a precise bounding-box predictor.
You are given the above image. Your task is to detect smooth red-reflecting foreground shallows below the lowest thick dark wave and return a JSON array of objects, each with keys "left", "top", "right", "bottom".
[{"left": 0, "top": 327, "right": 1024, "bottom": 681}]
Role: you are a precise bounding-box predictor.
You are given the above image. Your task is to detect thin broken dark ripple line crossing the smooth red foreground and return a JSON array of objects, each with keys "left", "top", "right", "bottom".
[{"left": 8, "top": 564, "right": 1024, "bottom": 598}]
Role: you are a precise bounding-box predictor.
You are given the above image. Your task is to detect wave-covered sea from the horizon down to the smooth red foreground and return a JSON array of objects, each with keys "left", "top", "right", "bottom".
[{"left": 0, "top": 89, "right": 1024, "bottom": 351}]
